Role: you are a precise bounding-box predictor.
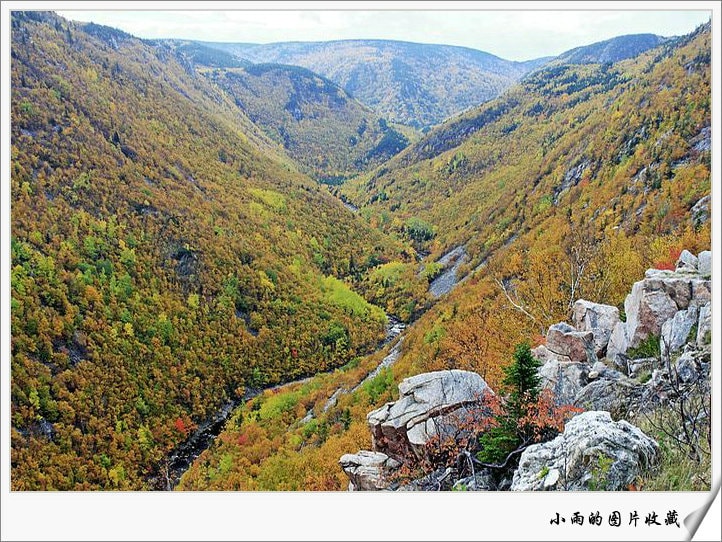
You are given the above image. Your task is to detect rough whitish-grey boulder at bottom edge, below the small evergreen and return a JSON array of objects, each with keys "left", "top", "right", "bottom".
[{"left": 511, "top": 411, "right": 659, "bottom": 491}]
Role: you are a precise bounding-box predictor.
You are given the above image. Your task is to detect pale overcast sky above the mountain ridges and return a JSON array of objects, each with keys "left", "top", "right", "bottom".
[{"left": 57, "top": 2, "right": 710, "bottom": 60}]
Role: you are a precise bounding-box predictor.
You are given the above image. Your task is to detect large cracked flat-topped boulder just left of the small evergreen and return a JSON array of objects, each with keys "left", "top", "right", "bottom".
[{"left": 366, "top": 369, "right": 493, "bottom": 461}]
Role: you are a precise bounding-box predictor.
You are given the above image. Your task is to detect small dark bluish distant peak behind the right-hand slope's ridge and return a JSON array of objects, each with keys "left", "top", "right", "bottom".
[{"left": 554, "top": 34, "right": 669, "bottom": 64}]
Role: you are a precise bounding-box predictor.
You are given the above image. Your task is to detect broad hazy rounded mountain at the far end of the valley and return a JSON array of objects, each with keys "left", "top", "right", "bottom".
[{"left": 197, "top": 40, "right": 538, "bottom": 128}]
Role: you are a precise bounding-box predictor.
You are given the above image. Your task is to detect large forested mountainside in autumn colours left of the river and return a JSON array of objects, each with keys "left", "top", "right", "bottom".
[{"left": 11, "top": 12, "right": 413, "bottom": 490}]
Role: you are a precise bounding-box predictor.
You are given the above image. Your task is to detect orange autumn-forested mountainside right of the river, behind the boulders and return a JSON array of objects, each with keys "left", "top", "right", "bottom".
[{"left": 179, "top": 24, "right": 712, "bottom": 490}]
